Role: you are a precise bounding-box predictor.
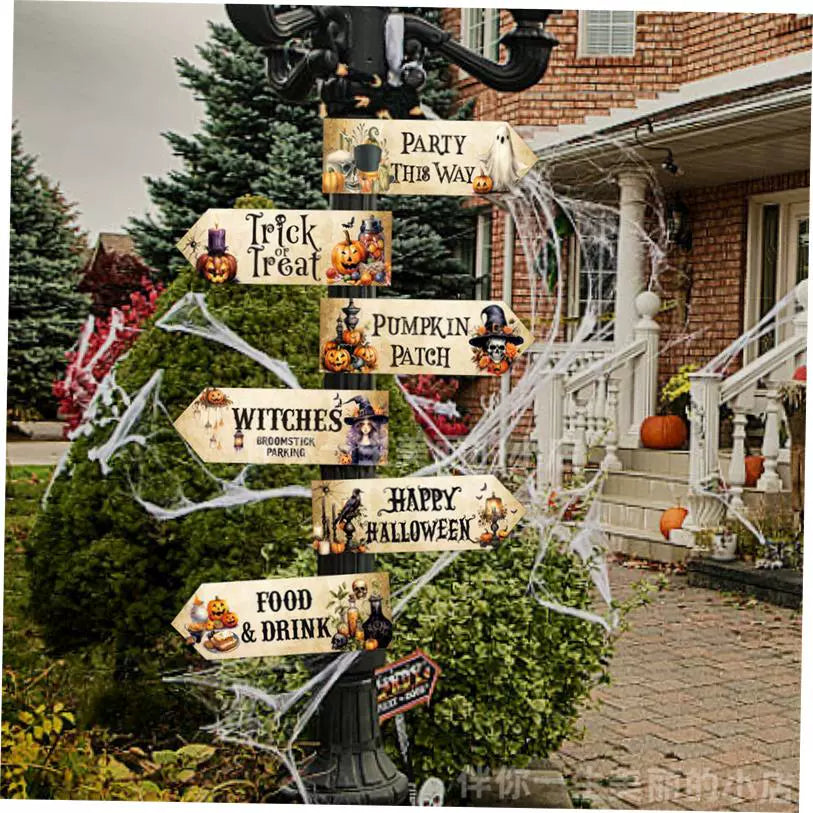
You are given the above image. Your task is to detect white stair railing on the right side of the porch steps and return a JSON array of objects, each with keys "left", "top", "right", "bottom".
[{"left": 683, "top": 280, "right": 807, "bottom": 532}]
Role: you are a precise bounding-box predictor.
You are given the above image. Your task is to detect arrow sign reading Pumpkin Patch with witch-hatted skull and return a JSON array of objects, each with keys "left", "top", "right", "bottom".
[{"left": 319, "top": 299, "right": 533, "bottom": 375}]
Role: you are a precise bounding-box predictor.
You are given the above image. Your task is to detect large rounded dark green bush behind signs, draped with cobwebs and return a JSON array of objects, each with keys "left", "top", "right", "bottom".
[{"left": 28, "top": 271, "right": 426, "bottom": 669}]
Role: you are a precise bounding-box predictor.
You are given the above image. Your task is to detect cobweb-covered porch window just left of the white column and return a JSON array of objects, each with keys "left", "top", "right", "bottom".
[{"left": 568, "top": 217, "right": 618, "bottom": 342}]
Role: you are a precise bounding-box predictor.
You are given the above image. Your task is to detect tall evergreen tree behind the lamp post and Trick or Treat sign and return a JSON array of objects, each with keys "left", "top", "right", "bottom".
[{"left": 129, "top": 9, "right": 474, "bottom": 298}]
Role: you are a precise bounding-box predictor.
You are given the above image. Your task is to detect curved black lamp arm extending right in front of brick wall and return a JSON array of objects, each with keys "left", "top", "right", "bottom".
[{"left": 404, "top": 9, "right": 558, "bottom": 92}]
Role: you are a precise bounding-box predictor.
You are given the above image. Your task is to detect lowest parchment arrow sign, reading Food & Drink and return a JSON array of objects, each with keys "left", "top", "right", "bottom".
[{"left": 172, "top": 573, "right": 392, "bottom": 660}]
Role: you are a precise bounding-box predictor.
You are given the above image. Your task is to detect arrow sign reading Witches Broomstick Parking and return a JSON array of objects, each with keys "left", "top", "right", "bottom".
[{"left": 175, "top": 387, "right": 389, "bottom": 466}]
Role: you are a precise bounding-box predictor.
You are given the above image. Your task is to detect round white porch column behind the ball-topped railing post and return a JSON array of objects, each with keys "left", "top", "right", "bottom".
[{"left": 613, "top": 170, "right": 647, "bottom": 447}]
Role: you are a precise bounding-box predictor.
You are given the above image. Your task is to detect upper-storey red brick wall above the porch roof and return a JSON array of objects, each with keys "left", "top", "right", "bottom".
[{"left": 443, "top": 9, "right": 813, "bottom": 127}]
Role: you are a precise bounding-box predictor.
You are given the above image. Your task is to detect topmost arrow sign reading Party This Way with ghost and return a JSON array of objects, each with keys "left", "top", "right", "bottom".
[{"left": 322, "top": 119, "right": 536, "bottom": 195}]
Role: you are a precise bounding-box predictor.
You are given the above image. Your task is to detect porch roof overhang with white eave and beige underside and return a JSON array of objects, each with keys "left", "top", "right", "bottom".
[{"left": 539, "top": 73, "right": 811, "bottom": 190}]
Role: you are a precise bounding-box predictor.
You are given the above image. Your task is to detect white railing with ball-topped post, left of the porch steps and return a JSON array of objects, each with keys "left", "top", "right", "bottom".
[{"left": 531, "top": 291, "right": 660, "bottom": 487}]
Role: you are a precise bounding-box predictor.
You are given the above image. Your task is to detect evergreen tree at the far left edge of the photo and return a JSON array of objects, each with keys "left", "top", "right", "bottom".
[{"left": 8, "top": 124, "right": 89, "bottom": 418}]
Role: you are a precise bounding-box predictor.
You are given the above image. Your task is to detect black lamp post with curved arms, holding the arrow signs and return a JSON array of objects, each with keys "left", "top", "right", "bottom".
[{"left": 226, "top": 5, "right": 557, "bottom": 804}]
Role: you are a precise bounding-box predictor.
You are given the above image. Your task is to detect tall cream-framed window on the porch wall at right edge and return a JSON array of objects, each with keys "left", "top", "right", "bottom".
[{"left": 744, "top": 189, "right": 810, "bottom": 363}]
